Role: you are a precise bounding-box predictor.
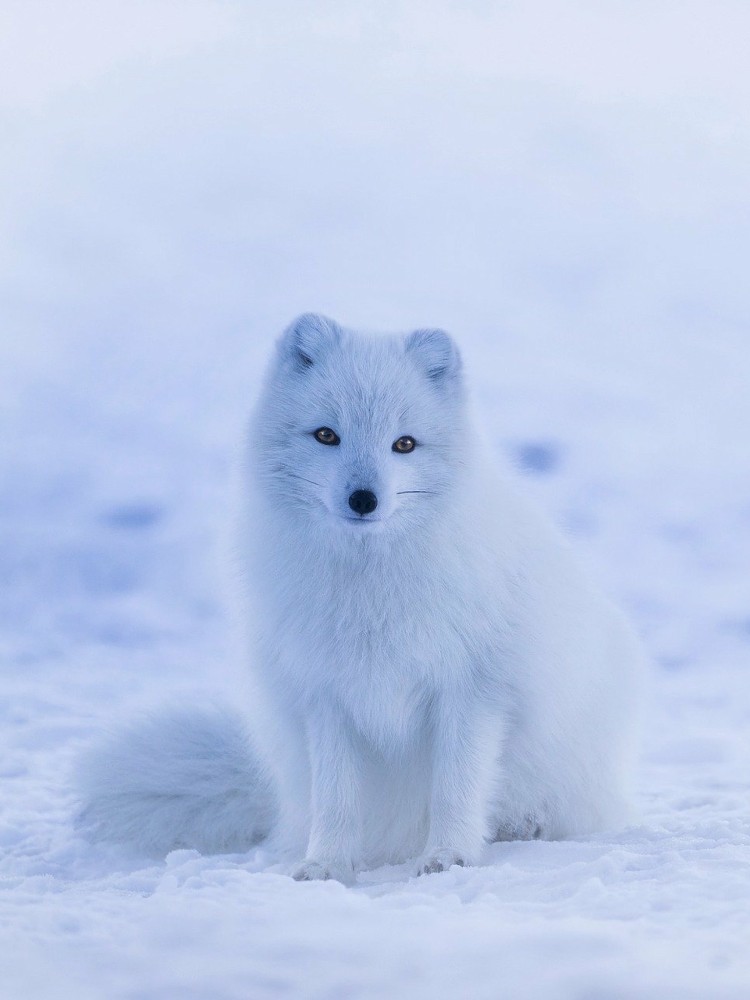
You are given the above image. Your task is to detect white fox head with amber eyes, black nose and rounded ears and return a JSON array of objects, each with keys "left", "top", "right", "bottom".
[{"left": 250, "top": 314, "right": 466, "bottom": 535}]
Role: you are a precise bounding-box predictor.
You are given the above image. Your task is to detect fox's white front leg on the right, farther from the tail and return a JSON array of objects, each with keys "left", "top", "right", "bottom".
[{"left": 418, "top": 702, "right": 501, "bottom": 875}]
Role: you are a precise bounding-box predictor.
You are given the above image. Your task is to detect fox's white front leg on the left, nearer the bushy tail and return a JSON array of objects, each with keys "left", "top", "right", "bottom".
[{"left": 293, "top": 708, "right": 362, "bottom": 885}]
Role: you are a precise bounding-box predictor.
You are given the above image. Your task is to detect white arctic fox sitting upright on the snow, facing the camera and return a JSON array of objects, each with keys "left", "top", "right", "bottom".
[{"left": 78, "top": 314, "right": 641, "bottom": 882}]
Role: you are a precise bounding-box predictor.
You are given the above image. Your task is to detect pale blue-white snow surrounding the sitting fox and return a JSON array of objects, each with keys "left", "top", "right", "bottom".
[{"left": 0, "top": 0, "right": 750, "bottom": 1000}]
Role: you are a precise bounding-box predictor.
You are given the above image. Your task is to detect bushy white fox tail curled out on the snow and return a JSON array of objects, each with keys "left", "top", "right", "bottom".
[{"left": 78, "top": 707, "right": 276, "bottom": 856}]
